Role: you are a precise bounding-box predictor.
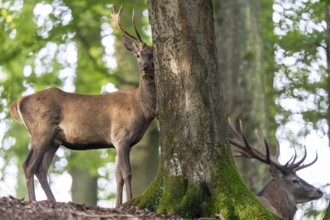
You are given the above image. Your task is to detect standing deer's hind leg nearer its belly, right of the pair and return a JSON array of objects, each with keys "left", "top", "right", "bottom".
[{"left": 36, "top": 146, "right": 59, "bottom": 202}]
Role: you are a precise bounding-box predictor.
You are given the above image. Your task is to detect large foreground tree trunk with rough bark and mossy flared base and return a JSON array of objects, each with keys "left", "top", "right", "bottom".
[{"left": 132, "top": 0, "right": 275, "bottom": 219}]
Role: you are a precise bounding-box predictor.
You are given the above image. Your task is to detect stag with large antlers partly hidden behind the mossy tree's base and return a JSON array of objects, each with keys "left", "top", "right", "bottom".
[{"left": 229, "top": 121, "right": 323, "bottom": 220}]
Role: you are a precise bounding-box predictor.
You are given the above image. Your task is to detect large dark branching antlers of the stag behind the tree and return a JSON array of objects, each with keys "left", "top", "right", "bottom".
[{"left": 228, "top": 119, "right": 318, "bottom": 174}]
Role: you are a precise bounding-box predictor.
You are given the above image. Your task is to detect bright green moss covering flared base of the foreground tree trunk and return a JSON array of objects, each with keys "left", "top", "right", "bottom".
[{"left": 133, "top": 151, "right": 281, "bottom": 220}]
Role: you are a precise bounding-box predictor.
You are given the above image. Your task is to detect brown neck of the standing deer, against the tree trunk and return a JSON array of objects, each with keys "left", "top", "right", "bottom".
[{"left": 136, "top": 71, "right": 156, "bottom": 119}]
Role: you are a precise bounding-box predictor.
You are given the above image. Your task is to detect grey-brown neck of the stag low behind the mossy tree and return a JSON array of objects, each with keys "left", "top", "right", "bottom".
[{"left": 258, "top": 179, "right": 297, "bottom": 220}]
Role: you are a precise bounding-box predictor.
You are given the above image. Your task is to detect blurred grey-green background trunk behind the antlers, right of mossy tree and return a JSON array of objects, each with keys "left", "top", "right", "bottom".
[{"left": 213, "top": 0, "right": 273, "bottom": 192}]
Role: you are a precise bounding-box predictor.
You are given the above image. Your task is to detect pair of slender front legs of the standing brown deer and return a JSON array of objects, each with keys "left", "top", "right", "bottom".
[{"left": 116, "top": 145, "right": 132, "bottom": 207}]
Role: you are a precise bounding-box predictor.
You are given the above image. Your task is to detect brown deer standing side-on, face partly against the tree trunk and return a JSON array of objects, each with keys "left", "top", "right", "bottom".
[{"left": 10, "top": 7, "right": 156, "bottom": 207}]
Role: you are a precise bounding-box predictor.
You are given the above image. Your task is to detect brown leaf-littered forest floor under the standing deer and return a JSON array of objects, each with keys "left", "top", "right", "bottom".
[{"left": 0, "top": 197, "right": 182, "bottom": 220}]
